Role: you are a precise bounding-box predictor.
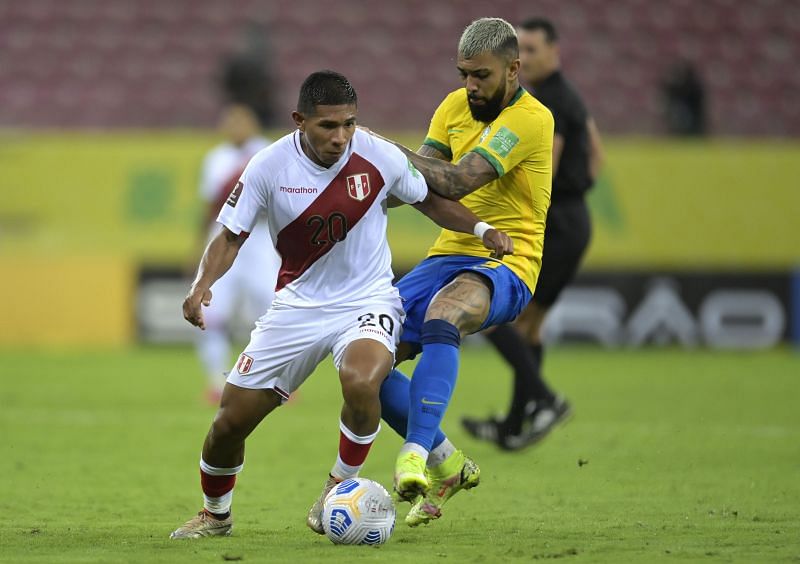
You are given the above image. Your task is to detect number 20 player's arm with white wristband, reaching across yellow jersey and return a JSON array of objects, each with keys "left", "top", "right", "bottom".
[{"left": 414, "top": 192, "right": 514, "bottom": 259}]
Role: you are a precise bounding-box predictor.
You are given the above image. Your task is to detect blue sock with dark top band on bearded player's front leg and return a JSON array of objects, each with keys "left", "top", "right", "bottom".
[{"left": 406, "top": 319, "right": 461, "bottom": 451}]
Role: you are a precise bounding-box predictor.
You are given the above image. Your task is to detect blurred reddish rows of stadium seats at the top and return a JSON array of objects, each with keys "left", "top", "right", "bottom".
[{"left": 0, "top": 0, "right": 800, "bottom": 136}]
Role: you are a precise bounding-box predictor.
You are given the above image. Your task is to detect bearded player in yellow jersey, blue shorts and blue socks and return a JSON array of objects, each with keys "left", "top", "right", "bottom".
[{"left": 372, "top": 18, "right": 553, "bottom": 524}]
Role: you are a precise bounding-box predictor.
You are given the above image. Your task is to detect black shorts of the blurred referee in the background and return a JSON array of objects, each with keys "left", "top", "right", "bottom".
[{"left": 532, "top": 199, "right": 592, "bottom": 308}]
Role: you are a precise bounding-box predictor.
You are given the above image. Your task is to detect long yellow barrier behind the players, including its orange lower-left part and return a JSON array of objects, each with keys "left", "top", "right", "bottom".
[{"left": 0, "top": 131, "right": 800, "bottom": 343}]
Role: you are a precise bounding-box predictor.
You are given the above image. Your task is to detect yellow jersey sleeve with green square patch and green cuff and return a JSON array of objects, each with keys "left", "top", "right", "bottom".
[{"left": 472, "top": 102, "right": 553, "bottom": 177}]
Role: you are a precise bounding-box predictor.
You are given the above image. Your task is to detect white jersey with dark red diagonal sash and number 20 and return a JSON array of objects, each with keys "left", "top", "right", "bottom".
[{"left": 218, "top": 130, "right": 428, "bottom": 307}]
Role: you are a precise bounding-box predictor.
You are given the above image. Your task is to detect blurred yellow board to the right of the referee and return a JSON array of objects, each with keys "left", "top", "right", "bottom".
[{"left": 587, "top": 140, "right": 800, "bottom": 271}]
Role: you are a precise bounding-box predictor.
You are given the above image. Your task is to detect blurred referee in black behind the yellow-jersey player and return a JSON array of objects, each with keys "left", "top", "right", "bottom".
[{"left": 462, "top": 18, "right": 602, "bottom": 450}]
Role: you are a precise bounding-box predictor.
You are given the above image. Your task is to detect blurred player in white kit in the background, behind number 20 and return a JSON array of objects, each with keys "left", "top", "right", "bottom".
[{"left": 195, "top": 104, "right": 280, "bottom": 405}]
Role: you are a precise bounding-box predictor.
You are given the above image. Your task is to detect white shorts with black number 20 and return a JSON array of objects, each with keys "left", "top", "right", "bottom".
[{"left": 228, "top": 296, "right": 405, "bottom": 402}]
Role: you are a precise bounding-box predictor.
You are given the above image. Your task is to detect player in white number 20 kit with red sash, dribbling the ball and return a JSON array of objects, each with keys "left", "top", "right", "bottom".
[{"left": 171, "top": 71, "right": 513, "bottom": 538}]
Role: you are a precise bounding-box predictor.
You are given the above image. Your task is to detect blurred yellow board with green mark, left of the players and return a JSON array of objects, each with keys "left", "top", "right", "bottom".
[{"left": 0, "top": 133, "right": 214, "bottom": 262}]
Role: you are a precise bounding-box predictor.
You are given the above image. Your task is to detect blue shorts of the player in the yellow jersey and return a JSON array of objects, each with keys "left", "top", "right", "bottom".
[{"left": 397, "top": 255, "right": 531, "bottom": 349}]
